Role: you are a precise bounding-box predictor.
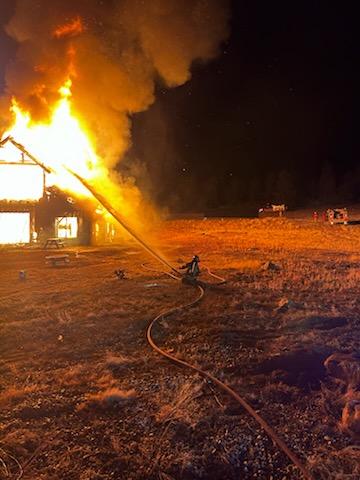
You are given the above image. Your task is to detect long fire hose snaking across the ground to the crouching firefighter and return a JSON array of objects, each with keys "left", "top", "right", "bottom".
[{"left": 142, "top": 265, "right": 314, "bottom": 480}]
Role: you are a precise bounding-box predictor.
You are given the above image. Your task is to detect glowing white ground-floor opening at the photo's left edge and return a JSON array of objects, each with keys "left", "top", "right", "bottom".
[{"left": 0, "top": 212, "right": 30, "bottom": 244}]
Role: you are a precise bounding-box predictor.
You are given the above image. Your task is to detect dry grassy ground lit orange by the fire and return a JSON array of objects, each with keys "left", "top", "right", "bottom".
[{"left": 0, "top": 219, "right": 360, "bottom": 480}]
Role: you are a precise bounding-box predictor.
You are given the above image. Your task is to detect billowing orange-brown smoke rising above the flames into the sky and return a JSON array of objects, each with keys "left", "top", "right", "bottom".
[{"left": 1, "top": 0, "right": 228, "bottom": 168}]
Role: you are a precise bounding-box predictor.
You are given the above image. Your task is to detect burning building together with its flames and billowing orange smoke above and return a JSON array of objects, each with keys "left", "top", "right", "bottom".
[{"left": 0, "top": 0, "right": 229, "bottom": 248}]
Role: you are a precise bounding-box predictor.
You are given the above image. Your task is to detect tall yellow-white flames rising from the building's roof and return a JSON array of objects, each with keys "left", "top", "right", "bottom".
[{"left": 0, "top": 80, "right": 106, "bottom": 199}]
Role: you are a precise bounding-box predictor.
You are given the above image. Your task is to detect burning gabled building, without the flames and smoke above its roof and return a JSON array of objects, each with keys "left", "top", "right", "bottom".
[{"left": 0, "top": 137, "right": 116, "bottom": 245}]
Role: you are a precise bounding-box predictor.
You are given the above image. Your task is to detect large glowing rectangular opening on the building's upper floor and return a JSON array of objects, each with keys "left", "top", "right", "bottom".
[{"left": 0, "top": 161, "right": 44, "bottom": 201}]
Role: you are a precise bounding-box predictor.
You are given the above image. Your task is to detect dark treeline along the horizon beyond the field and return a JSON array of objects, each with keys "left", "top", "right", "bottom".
[{"left": 167, "top": 164, "right": 360, "bottom": 211}]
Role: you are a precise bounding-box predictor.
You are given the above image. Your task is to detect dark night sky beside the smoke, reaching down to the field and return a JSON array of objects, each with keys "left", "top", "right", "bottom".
[{"left": 0, "top": 0, "right": 360, "bottom": 210}]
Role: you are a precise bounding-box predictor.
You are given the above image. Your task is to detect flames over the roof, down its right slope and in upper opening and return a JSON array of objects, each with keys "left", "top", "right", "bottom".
[{"left": 0, "top": 78, "right": 141, "bottom": 227}]
